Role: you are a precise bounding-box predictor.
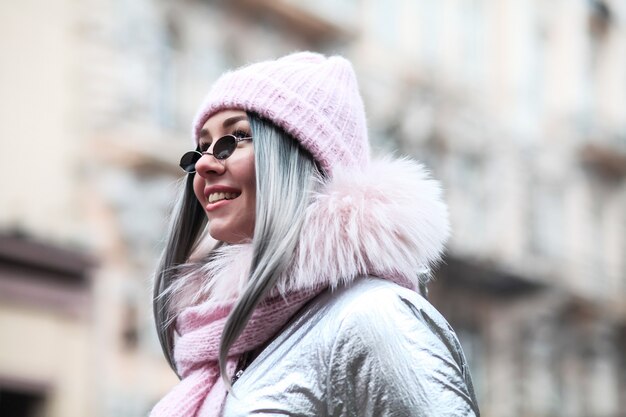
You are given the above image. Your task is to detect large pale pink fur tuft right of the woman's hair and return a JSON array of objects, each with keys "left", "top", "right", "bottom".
[{"left": 283, "top": 158, "right": 449, "bottom": 291}]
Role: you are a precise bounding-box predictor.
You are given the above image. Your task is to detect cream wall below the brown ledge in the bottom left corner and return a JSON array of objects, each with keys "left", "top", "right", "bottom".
[{"left": 0, "top": 303, "right": 94, "bottom": 417}]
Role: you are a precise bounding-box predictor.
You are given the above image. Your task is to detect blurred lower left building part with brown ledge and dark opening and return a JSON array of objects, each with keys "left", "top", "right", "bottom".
[{"left": 0, "top": 235, "right": 93, "bottom": 417}]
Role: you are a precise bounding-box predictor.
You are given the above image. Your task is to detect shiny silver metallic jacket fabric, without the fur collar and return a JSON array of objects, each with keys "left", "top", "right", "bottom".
[{"left": 224, "top": 278, "right": 479, "bottom": 417}]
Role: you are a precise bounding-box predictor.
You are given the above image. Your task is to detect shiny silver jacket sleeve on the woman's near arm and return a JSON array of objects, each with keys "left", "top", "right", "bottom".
[{"left": 327, "top": 290, "right": 479, "bottom": 417}]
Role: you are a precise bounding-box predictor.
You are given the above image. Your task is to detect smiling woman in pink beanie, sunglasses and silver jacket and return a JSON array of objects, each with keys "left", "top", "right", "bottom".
[{"left": 152, "top": 52, "right": 478, "bottom": 416}]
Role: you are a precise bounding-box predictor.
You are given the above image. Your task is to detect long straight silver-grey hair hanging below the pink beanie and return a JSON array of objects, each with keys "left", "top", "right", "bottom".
[{"left": 153, "top": 113, "right": 322, "bottom": 376}]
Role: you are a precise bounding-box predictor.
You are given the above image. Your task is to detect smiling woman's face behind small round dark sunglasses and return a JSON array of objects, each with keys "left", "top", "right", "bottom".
[{"left": 193, "top": 110, "right": 256, "bottom": 243}]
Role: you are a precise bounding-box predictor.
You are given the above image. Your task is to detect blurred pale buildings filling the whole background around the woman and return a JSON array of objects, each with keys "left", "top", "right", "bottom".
[{"left": 0, "top": 0, "right": 626, "bottom": 417}]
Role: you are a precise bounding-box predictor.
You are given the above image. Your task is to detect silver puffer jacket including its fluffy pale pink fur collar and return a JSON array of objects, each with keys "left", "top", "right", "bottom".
[{"left": 173, "top": 158, "right": 478, "bottom": 417}]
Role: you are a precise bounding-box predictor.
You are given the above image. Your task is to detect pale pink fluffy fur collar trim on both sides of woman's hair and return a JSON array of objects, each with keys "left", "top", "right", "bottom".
[{"left": 170, "top": 157, "right": 449, "bottom": 311}]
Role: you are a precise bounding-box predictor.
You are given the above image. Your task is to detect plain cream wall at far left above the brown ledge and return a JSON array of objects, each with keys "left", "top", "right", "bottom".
[{"left": 0, "top": 0, "right": 81, "bottom": 241}]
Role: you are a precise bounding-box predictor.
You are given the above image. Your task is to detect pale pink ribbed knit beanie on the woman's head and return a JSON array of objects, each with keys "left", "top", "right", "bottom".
[{"left": 193, "top": 52, "right": 369, "bottom": 174}]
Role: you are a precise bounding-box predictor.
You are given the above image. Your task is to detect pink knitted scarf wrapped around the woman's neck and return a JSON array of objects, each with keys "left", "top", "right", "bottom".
[{"left": 150, "top": 291, "right": 319, "bottom": 417}]
